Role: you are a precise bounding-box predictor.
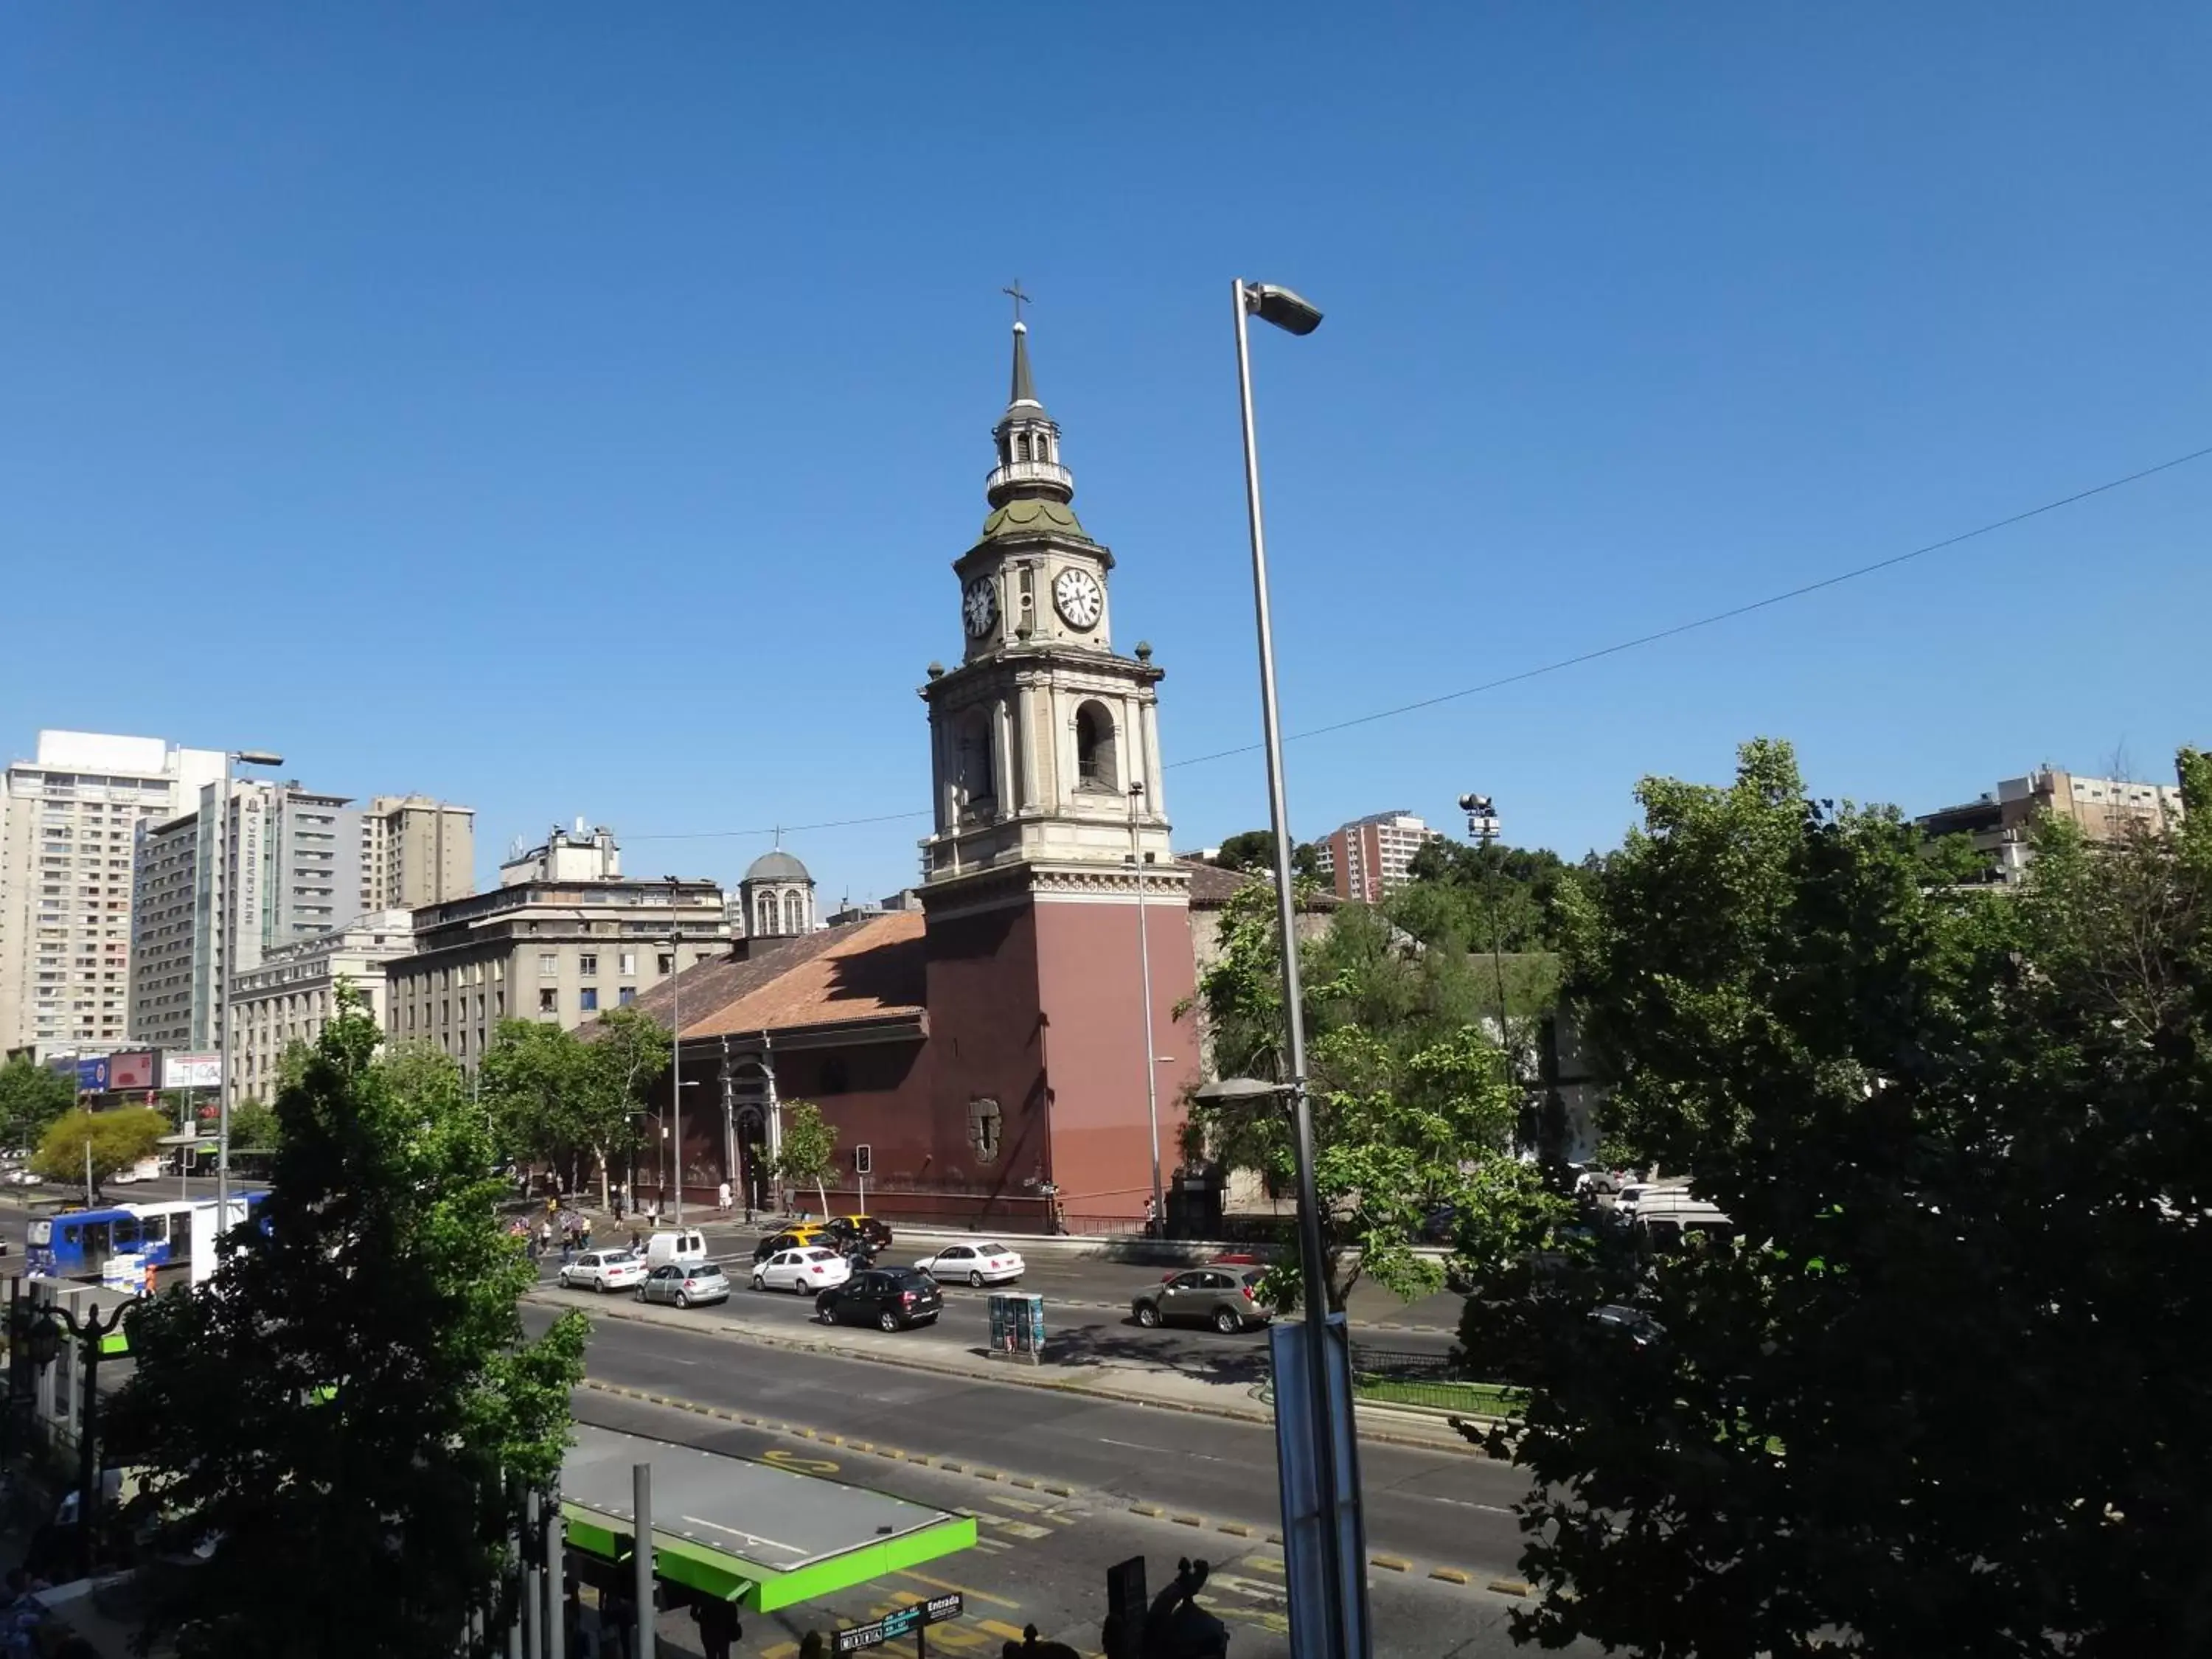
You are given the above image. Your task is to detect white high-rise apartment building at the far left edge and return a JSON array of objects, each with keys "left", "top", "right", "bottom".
[{"left": 0, "top": 732, "right": 223, "bottom": 1057}]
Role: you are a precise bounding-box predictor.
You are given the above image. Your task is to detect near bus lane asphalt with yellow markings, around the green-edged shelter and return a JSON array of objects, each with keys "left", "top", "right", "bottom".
[{"left": 575, "top": 1389, "right": 1597, "bottom": 1659}]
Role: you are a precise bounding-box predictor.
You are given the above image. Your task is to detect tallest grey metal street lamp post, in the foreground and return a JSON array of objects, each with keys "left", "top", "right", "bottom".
[{"left": 1230, "top": 279, "right": 1365, "bottom": 1659}]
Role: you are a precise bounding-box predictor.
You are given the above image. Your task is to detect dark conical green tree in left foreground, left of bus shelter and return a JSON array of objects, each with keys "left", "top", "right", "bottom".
[{"left": 108, "top": 995, "right": 586, "bottom": 1659}]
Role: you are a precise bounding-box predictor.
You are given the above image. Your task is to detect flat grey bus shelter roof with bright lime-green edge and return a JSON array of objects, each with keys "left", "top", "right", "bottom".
[{"left": 560, "top": 1422, "right": 975, "bottom": 1613}]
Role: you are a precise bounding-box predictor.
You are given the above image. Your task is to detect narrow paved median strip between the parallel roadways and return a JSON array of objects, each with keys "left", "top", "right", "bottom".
[{"left": 540, "top": 1287, "right": 1486, "bottom": 1455}]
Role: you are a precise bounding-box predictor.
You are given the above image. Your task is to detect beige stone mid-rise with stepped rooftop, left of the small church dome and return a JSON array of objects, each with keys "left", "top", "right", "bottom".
[{"left": 385, "top": 821, "right": 730, "bottom": 1071}]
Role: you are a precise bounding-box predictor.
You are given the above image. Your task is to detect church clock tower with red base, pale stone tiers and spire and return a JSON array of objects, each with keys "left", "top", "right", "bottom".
[{"left": 920, "top": 319, "right": 1197, "bottom": 1219}]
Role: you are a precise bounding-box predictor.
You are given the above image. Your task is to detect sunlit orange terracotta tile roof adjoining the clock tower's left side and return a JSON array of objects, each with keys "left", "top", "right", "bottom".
[{"left": 637, "top": 911, "right": 925, "bottom": 1040}]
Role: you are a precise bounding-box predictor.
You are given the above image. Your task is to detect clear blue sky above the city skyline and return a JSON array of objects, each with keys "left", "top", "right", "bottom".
[{"left": 0, "top": 0, "right": 2212, "bottom": 900}]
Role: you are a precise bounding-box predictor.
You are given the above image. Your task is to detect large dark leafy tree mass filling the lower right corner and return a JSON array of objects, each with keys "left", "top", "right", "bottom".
[{"left": 1467, "top": 743, "right": 2212, "bottom": 1659}]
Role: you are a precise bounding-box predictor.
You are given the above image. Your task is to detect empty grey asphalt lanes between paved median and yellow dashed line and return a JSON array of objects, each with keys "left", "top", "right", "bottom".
[{"left": 538, "top": 1303, "right": 1528, "bottom": 1582}]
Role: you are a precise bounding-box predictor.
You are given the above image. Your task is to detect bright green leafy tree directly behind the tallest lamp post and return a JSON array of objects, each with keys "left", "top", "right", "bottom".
[{"left": 1188, "top": 887, "right": 1546, "bottom": 1307}]
